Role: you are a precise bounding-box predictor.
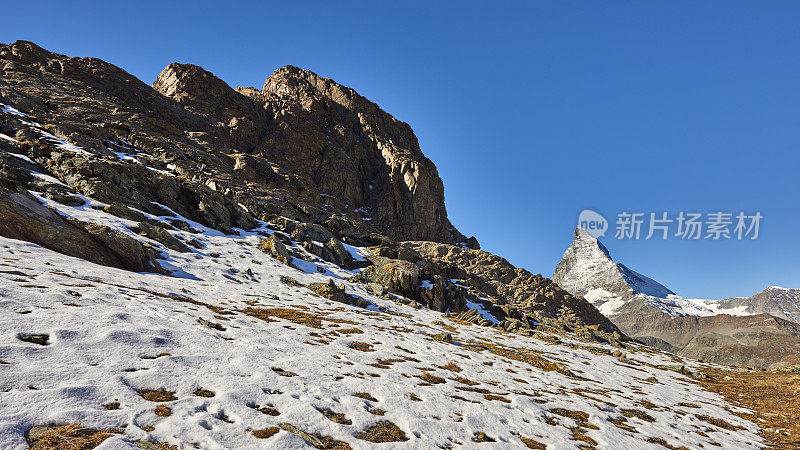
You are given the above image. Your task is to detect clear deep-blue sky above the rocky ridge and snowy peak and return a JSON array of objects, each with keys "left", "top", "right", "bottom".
[{"left": 0, "top": 0, "right": 800, "bottom": 298}]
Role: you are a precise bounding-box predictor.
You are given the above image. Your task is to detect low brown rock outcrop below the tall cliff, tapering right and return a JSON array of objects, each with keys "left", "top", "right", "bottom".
[{"left": 348, "top": 241, "right": 623, "bottom": 343}]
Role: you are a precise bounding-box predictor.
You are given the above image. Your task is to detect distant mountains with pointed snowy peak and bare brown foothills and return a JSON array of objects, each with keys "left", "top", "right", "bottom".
[{"left": 553, "top": 228, "right": 800, "bottom": 368}]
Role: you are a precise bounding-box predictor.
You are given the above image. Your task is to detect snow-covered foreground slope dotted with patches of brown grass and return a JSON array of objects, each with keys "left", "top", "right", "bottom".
[{"left": 0, "top": 205, "right": 760, "bottom": 449}]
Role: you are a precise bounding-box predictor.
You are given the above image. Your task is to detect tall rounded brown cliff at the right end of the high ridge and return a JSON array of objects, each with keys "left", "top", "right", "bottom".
[{"left": 253, "top": 66, "right": 463, "bottom": 243}]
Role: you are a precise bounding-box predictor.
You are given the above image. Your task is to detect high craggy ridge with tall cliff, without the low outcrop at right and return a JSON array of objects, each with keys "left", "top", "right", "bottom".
[{"left": 0, "top": 41, "right": 468, "bottom": 246}]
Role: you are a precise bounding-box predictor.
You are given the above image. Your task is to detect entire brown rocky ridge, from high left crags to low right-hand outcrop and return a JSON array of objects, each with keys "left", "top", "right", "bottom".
[{"left": 0, "top": 42, "right": 621, "bottom": 348}]
